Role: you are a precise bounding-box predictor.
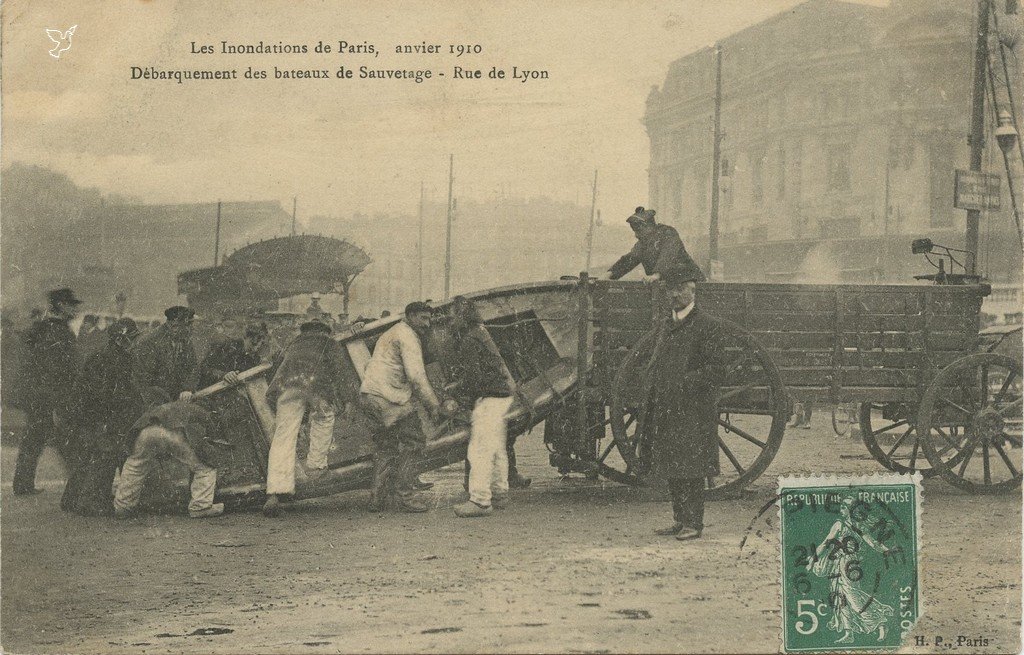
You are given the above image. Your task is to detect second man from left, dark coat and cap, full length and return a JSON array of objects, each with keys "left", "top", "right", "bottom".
[{"left": 60, "top": 318, "right": 143, "bottom": 516}]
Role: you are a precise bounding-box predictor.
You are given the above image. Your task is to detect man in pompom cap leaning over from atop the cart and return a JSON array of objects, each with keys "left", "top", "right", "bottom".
[{"left": 608, "top": 207, "right": 707, "bottom": 281}]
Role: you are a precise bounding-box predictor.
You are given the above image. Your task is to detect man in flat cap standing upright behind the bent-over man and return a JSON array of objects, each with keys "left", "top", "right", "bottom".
[{"left": 134, "top": 305, "right": 199, "bottom": 406}]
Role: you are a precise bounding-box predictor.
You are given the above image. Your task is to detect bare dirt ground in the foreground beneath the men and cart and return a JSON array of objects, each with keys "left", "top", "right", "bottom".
[{"left": 0, "top": 413, "right": 1021, "bottom": 653}]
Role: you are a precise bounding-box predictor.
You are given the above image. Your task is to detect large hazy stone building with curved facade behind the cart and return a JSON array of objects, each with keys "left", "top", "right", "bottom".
[{"left": 644, "top": 0, "right": 1024, "bottom": 292}]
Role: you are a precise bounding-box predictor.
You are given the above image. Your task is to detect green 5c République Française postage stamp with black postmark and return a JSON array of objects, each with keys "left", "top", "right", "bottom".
[{"left": 779, "top": 474, "right": 921, "bottom": 652}]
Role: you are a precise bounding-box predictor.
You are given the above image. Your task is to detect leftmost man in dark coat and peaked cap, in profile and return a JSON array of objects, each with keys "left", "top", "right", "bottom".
[{"left": 13, "top": 289, "right": 82, "bottom": 495}]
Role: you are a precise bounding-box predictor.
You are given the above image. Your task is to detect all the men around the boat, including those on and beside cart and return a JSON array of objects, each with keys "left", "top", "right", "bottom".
[{"left": 13, "top": 207, "right": 723, "bottom": 539}]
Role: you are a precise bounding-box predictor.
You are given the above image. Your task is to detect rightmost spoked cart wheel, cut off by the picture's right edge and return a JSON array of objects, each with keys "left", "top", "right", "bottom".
[{"left": 918, "top": 353, "right": 1024, "bottom": 493}]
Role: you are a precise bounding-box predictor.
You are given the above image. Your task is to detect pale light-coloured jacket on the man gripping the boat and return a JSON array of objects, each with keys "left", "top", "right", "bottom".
[{"left": 359, "top": 321, "right": 437, "bottom": 405}]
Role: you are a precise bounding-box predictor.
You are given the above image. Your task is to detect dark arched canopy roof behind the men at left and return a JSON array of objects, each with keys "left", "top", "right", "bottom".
[{"left": 178, "top": 234, "right": 373, "bottom": 314}]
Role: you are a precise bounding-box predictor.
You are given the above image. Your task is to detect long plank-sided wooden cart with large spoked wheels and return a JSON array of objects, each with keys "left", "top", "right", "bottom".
[{"left": 547, "top": 277, "right": 1024, "bottom": 497}]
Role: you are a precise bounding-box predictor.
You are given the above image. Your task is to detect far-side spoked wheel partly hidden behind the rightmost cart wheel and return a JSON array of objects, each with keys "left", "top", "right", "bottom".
[{"left": 860, "top": 402, "right": 965, "bottom": 478}]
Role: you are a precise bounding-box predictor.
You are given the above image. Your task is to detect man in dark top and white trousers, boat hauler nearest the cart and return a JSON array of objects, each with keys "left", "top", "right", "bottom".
[{"left": 452, "top": 296, "right": 515, "bottom": 518}]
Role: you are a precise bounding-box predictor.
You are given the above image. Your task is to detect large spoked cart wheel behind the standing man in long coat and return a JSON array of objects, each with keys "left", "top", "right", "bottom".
[{"left": 599, "top": 320, "right": 790, "bottom": 499}]
